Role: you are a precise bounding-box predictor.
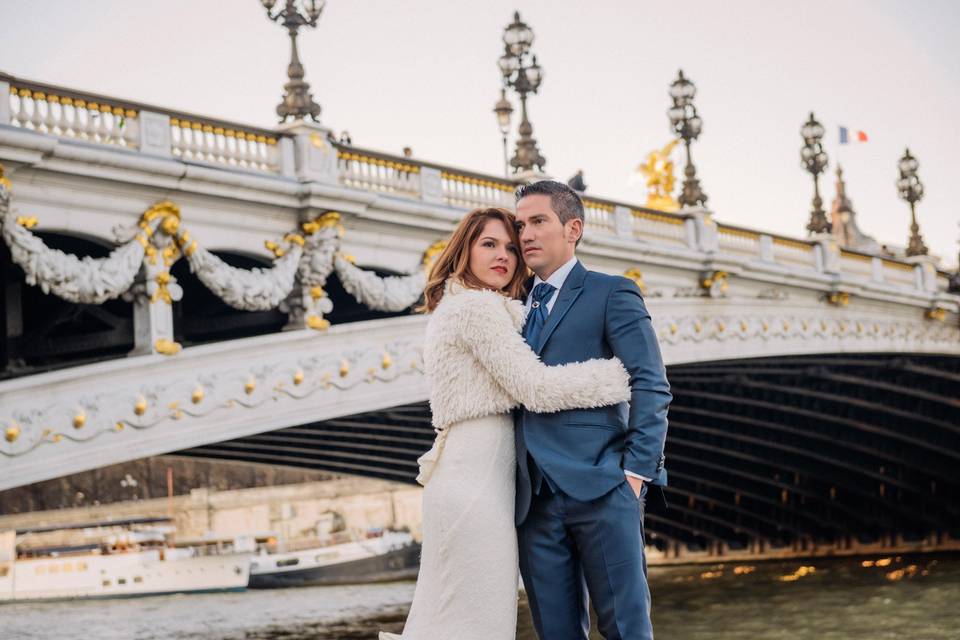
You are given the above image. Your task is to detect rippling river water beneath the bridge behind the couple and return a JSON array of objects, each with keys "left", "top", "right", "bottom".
[{"left": 0, "top": 555, "right": 960, "bottom": 640}]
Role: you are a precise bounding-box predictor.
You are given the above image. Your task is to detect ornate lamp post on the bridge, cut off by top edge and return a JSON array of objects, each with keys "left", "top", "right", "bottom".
[{"left": 260, "top": 0, "right": 326, "bottom": 122}]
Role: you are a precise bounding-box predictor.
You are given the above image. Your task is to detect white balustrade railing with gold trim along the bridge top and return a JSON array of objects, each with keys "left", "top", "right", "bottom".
[{"left": 0, "top": 73, "right": 948, "bottom": 290}]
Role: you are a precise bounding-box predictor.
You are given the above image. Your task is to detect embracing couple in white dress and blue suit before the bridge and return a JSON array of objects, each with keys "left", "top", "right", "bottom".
[{"left": 380, "top": 180, "right": 671, "bottom": 640}]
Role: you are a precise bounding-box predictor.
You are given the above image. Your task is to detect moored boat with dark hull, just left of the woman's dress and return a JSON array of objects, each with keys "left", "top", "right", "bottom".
[{"left": 250, "top": 529, "right": 420, "bottom": 589}]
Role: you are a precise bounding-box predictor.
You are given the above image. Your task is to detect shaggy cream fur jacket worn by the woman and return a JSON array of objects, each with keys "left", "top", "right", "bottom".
[{"left": 417, "top": 280, "right": 630, "bottom": 485}]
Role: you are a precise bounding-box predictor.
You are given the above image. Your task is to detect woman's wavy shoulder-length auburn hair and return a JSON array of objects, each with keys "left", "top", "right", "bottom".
[{"left": 417, "top": 207, "right": 527, "bottom": 313}]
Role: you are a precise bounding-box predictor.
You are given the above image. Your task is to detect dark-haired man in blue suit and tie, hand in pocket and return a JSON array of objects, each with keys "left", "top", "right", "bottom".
[{"left": 516, "top": 180, "right": 671, "bottom": 640}]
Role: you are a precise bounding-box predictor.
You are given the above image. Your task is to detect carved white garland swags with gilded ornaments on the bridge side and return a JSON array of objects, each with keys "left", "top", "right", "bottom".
[{"left": 0, "top": 167, "right": 442, "bottom": 342}]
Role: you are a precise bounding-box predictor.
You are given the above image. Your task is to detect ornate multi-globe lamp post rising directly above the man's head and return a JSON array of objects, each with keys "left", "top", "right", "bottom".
[{"left": 499, "top": 11, "right": 547, "bottom": 173}]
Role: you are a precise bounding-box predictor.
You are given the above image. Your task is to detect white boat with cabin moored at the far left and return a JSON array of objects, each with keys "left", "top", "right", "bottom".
[{"left": 0, "top": 519, "right": 252, "bottom": 603}]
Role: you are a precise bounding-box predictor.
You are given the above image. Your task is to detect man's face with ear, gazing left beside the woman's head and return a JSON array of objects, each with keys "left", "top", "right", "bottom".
[{"left": 517, "top": 193, "right": 583, "bottom": 280}]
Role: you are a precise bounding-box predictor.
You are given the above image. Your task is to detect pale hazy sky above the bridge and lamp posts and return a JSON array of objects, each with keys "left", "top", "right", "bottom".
[{"left": 0, "top": 0, "right": 960, "bottom": 265}]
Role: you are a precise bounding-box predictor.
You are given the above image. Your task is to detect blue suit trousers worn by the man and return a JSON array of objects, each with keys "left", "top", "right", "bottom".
[{"left": 517, "top": 479, "right": 653, "bottom": 640}]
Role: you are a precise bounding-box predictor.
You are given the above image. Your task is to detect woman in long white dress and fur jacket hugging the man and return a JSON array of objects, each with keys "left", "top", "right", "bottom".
[{"left": 380, "top": 208, "right": 629, "bottom": 640}]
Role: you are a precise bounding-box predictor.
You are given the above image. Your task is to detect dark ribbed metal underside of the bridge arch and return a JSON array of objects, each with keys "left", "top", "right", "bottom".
[{"left": 177, "top": 354, "right": 960, "bottom": 550}]
